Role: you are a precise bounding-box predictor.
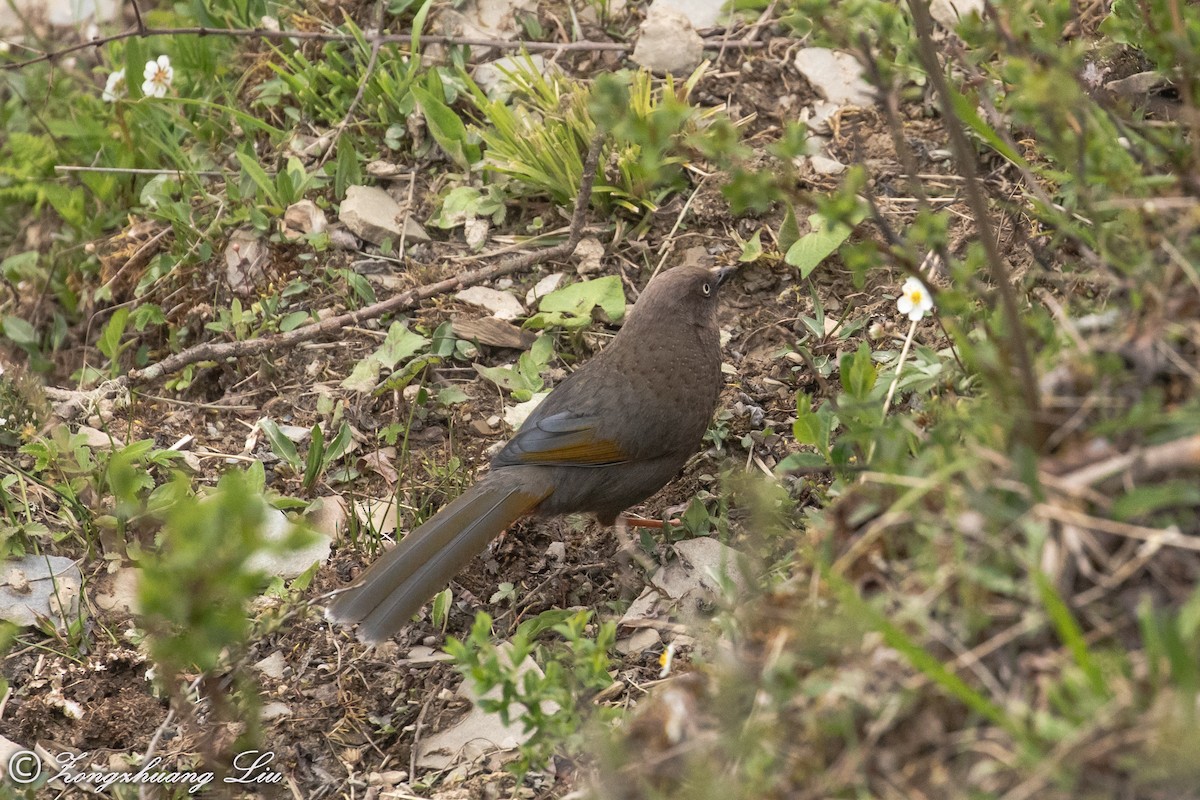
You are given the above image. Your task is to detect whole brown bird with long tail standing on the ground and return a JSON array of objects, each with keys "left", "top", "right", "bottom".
[{"left": 326, "top": 266, "right": 732, "bottom": 642}]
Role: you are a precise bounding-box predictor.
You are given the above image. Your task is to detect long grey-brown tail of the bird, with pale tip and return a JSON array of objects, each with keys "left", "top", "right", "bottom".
[{"left": 325, "top": 476, "right": 548, "bottom": 642}]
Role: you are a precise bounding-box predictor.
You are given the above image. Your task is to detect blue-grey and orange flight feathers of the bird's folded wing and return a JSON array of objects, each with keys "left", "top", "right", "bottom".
[{"left": 492, "top": 411, "right": 629, "bottom": 467}]
